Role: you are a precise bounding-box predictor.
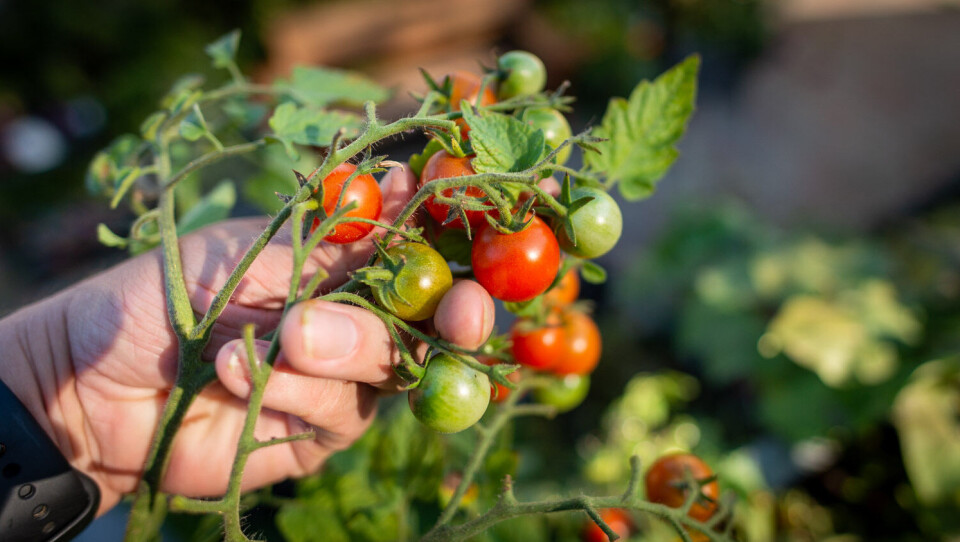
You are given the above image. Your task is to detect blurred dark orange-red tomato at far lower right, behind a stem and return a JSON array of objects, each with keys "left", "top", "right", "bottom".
[{"left": 644, "top": 453, "right": 720, "bottom": 521}]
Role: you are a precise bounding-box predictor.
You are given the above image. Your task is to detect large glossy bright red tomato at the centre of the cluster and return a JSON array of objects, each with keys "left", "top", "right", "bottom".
[{"left": 470, "top": 216, "right": 560, "bottom": 301}]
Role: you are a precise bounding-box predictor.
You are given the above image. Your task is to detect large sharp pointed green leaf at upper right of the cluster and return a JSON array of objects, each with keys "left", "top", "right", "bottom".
[{"left": 584, "top": 56, "right": 700, "bottom": 200}]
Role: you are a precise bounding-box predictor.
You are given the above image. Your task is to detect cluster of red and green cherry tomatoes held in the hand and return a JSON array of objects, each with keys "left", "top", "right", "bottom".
[{"left": 313, "top": 51, "right": 622, "bottom": 433}]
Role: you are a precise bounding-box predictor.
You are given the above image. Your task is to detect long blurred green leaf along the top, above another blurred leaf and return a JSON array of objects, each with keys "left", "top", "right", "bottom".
[{"left": 274, "top": 66, "right": 390, "bottom": 107}]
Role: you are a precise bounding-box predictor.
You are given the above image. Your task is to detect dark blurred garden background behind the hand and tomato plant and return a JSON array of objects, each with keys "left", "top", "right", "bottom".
[{"left": 0, "top": 0, "right": 960, "bottom": 542}]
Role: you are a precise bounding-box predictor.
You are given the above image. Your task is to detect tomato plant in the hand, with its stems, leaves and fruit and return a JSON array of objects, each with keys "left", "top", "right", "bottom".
[{"left": 88, "top": 29, "right": 699, "bottom": 542}]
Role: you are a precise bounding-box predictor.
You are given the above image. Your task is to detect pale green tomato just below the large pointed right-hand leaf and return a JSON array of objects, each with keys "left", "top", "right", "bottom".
[{"left": 557, "top": 187, "right": 623, "bottom": 259}]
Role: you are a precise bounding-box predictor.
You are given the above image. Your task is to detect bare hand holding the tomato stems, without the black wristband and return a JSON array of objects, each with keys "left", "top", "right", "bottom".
[{"left": 0, "top": 170, "right": 494, "bottom": 513}]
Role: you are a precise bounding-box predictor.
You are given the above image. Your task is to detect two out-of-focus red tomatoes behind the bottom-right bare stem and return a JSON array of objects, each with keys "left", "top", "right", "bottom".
[{"left": 582, "top": 453, "right": 720, "bottom": 542}]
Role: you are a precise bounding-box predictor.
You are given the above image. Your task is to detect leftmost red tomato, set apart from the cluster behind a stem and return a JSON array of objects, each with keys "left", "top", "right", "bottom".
[{"left": 310, "top": 163, "right": 383, "bottom": 244}]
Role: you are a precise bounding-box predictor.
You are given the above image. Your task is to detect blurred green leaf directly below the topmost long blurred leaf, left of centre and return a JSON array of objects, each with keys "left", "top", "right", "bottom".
[{"left": 270, "top": 102, "right": 362, "bottom": 160}]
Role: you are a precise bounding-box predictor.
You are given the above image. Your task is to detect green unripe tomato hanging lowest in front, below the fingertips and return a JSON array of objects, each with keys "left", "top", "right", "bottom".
[{"left": 407, "top": 354, "right": 490, "bottom": 433}]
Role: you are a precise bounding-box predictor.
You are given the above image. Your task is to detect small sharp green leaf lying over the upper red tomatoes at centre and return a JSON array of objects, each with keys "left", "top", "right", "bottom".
[{"left": 463, "top": 105, "right": 546, "bottom": 173}]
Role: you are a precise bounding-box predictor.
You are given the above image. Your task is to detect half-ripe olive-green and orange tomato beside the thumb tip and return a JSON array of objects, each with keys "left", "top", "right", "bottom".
[{"left": 372, "top": 242, "right": 453, "bottom": 322}]
